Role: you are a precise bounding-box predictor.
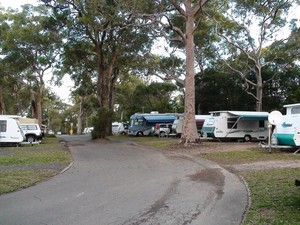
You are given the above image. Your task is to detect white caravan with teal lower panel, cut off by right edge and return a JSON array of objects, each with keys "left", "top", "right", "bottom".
[{"left": 272, "top": 103, "right": 300, "bottom": 147}]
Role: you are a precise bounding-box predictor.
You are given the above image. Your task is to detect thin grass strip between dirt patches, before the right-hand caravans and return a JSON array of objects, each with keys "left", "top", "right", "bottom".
[{"left": 199, "top": 149, "right": 300, "bottom": 165}]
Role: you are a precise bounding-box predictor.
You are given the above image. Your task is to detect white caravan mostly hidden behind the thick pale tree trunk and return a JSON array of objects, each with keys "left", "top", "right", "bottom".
[{"left": 171, "top": 114, "right": 209, "bottom": 137}]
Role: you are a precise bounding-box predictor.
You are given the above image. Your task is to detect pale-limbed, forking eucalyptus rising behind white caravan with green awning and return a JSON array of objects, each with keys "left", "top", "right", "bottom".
[{"left": 214, "top": 0, "right": 299, "bottom": 111}]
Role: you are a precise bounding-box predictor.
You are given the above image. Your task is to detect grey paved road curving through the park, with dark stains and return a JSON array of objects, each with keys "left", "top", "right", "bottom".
[{"left": 0, "top": 136, "right": 247, "bottom": 225}]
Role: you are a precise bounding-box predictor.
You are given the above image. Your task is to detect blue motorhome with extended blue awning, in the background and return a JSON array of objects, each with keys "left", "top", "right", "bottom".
[{"left": 128, "top": 112, "right": 176, "bottom": 136}]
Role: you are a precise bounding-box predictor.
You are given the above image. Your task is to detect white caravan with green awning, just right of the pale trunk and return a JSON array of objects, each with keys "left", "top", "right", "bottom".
[{"left": 202, "top": 111, "right": 269, "bottom": 141}]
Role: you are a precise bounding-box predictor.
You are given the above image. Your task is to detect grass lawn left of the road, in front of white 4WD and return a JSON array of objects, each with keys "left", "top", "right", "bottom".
[{"left": 0, "top": 138, "right": 72, "bottom": 194}]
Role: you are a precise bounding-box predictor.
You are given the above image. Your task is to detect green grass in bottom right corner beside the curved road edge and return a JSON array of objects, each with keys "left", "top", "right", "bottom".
[{"left": 242, "top": 168, "right": 300, "bottom": 225}]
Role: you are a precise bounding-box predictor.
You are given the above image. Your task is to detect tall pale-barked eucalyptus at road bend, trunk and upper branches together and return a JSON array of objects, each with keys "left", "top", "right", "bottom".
[{"left": 149, "top": 0, "right": 208, "bottom": 145}]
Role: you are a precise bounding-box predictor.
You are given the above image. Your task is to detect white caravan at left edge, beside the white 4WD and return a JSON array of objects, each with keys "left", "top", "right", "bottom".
[{"left": 0, "top": 116, "right": 25, "bottom": 145}]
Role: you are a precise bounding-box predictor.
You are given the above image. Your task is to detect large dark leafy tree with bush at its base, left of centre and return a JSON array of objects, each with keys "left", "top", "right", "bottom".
[{"left": 43, "top": 0, "right": 152, "bottom": 138}]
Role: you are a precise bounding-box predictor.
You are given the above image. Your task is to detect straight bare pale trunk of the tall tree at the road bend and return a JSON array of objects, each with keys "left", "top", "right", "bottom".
[{"left": 181, "top": 4, "right": 200, "bottom": 145}]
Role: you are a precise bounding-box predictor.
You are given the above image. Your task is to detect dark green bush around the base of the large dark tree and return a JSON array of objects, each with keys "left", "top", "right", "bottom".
[{"left": 92, "top": 108, "right": 113, "bottom": 139}]
